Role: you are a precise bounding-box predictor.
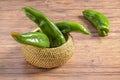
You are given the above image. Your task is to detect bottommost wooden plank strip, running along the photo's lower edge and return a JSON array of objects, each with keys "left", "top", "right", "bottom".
[{"left": 1, "top": 74, "right": 120, "bottom": 80}]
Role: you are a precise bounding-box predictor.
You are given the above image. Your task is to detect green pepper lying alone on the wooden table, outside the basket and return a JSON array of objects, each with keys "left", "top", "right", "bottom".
[{"left": 83, "top": 10, "right": 110, "bottom": 36}]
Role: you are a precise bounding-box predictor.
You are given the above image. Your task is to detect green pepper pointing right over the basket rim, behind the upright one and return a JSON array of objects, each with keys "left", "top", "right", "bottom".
[{"left": 55, "top": 21, "right": 90, "bottom": 34}]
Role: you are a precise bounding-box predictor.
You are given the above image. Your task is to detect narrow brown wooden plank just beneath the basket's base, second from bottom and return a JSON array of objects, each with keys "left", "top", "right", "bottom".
[{"left": 0, "top": 67, "right": 120, "bottom": 76}]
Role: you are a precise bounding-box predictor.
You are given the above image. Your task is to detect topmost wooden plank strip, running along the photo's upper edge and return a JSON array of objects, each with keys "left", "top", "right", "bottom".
[{"left": 0, "top": 0, "right": 120, "bottom": 10}]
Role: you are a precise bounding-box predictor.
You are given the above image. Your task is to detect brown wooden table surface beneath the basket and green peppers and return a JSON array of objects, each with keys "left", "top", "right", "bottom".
[{"left": 0, "top": 0, "right": 120, "bottom": 80}]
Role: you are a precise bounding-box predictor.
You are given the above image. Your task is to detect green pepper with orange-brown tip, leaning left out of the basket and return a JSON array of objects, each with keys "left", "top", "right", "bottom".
[{"left": 11, "top": 32, "right": 50, "bottom": 48}]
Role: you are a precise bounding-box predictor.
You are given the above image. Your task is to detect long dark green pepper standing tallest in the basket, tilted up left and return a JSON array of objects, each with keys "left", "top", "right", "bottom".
[{"left": 23, "top": 7, "right": 66, "bottom": 47}]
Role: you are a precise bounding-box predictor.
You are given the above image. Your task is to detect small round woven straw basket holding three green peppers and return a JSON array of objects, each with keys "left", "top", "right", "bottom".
[{"left": 21, "top": 29, "right": 74, "bottom": 68}]
